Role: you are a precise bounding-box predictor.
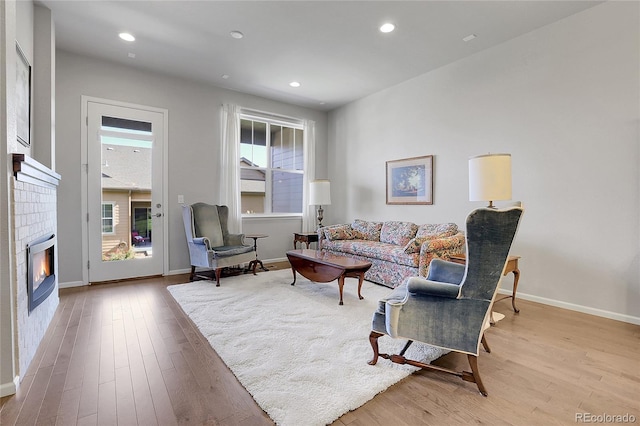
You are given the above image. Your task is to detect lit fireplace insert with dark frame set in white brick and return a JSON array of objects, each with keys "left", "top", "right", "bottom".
[{"left": 27, "top": 234, "right": 56, "bottom": 314}]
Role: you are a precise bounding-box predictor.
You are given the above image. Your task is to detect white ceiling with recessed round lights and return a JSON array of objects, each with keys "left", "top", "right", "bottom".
[{"left": 36, "top": 0, "right": 601, "bottom": 110}]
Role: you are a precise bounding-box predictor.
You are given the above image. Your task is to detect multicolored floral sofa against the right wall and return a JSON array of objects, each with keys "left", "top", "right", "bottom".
[{"left": 318, "top": 219, "right": 465, "bottom": 288}]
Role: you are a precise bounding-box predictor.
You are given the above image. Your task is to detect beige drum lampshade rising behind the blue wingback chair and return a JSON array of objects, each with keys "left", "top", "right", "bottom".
[{"left": 469, "top": 154, "right": 511, "bottom": 208}]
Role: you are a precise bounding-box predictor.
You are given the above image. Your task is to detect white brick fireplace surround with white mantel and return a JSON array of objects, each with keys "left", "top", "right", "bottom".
[{"left": 10, "top": 154, "right": 60, "bottom": 378}]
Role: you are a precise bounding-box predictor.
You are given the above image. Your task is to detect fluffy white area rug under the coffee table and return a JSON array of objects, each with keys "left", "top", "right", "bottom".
[{"left": 168, "top": 270, "right": 447, "bottom": 426}]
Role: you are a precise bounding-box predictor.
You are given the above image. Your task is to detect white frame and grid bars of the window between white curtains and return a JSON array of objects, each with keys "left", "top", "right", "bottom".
[{"left": 237, "top": 110, "right": 307, "bottom": 219}]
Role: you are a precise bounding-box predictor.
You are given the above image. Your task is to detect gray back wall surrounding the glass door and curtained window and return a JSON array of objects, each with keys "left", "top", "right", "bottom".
[{"left": 55, "top": 50, "right": 327, "bottom": 285}]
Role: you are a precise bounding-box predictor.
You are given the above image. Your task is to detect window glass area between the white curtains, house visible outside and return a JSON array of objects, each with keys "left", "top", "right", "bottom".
[{"left": 240, "top": 116, "right": 304, "bottom": 214}]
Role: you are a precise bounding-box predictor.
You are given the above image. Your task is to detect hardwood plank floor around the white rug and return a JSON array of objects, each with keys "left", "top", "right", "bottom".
[{"left": 0, "top": 265, "right": 640, "bottom": 426}]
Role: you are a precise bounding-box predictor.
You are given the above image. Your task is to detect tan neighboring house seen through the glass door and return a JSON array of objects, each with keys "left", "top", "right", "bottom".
[{"left": 102, "top": 144, "right": 152, "bottom": 253}]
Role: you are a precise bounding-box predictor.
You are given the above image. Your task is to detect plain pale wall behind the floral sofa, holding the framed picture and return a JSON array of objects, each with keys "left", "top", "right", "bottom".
[{"left": 325, "top": 2, "right": 640, "bottom": 323}]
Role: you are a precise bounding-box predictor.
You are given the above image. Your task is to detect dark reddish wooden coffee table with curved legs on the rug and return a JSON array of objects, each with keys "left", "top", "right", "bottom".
[{"left": 287, "top": 249, "right": 371, "bottom": 305}]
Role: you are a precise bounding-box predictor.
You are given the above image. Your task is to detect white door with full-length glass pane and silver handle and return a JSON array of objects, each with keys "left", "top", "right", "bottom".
[{"left": 86, "top": 100, "right": 165, "bottom": 282}]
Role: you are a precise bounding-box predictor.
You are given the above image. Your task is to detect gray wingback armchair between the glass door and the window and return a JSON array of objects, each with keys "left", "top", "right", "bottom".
[{"left": 182, "top": 203, "right": 255, "bottom": 286}]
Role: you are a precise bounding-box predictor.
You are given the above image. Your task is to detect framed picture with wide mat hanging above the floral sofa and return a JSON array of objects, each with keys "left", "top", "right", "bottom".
[{"left": 387, "top": 155, "right": 433, "bottom": 205}]
